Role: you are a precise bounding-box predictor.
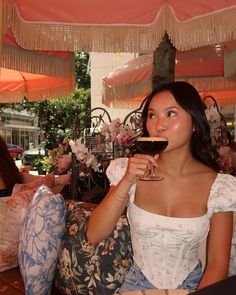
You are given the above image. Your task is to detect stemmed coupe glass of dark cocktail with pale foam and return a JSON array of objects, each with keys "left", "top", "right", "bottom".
[{"left": 135, "top": 137, "right": 168, "bottom": 180}]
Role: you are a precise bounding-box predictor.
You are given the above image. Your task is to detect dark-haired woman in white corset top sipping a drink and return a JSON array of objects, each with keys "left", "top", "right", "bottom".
[{"left": 87, "top": 82, "right": 236, "bottom": 293}]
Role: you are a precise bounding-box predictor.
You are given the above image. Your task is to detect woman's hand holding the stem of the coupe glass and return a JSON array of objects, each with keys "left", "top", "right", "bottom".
[{"left": 124, "top": 154, "right": 159, "bottom": 185}]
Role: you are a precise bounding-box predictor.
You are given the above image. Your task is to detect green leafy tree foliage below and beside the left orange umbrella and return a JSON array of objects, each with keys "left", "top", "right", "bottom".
[{"left": 0, "top": 52, "right": 91, "bottom": 149}]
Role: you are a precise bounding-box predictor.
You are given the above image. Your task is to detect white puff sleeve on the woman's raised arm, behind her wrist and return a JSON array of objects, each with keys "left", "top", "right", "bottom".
[{"left": 106, "top": 158, "right": 128, "bottom": 185}]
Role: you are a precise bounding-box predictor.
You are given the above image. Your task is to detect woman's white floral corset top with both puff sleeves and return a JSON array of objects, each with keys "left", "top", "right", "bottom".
[{"left": 107, "top": 158, "right": 236, "bottom": 289}]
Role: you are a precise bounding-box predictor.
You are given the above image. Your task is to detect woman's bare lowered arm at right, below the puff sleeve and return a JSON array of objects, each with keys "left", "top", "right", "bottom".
[{"left": 198, "top": 212, "right": 233, "bottom": 289}]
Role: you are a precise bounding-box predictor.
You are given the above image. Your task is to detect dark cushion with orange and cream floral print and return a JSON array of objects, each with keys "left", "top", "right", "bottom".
[{"left": 55, "top": 202, "right": 133, "bottom": 295}]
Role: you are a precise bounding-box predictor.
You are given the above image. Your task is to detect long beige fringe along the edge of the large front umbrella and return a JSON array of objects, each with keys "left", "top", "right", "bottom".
[{"left": 4, "top": 0, "right": 236, "bottom": 52}]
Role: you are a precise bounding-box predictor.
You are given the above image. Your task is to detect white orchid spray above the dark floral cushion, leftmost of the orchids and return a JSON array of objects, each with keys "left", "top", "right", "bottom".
[{"left": 69, "top": 139, "right": 100, "bottom": 176}]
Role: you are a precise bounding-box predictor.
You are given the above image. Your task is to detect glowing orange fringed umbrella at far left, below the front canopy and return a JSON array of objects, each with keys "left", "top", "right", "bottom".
[{"left": 0, "top": 30, "right": 75, "bottom": 103}]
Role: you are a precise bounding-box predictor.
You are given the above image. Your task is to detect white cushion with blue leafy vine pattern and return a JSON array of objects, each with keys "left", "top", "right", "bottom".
[{"left": 18, "top": 185, "right": 66, "bottom": 295}]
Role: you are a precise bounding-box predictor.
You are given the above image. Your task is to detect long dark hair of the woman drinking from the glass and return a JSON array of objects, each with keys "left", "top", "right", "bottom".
[{"left": 142, "top": 81, "right": 220, "bottom": 172}]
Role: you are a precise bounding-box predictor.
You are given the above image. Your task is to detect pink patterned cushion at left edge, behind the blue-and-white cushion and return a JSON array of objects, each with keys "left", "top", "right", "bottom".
[{"left": 0, "top": 191, "right": 33, "bottom": 271}]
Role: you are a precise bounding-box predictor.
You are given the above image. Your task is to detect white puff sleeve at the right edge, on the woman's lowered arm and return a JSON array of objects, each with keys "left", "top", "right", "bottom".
[{"left": 208, "top": 174, "right": 236, "bottom": 217}]
